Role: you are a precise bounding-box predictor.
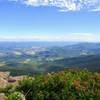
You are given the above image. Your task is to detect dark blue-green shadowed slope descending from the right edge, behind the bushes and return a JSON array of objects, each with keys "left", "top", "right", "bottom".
[{"left": 45, "top": 54, "right": 100, "bottom": 72}]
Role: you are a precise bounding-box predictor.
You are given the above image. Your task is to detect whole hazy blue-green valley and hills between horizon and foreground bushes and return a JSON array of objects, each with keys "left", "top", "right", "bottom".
[{"left": 0, "top": 42, "right": 100, "bottom": 75}]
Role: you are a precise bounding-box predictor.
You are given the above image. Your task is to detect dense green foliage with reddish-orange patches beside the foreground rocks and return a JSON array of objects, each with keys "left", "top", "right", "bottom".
[{"left": 16, "top": 70, "right": 100, "bottom": 100}]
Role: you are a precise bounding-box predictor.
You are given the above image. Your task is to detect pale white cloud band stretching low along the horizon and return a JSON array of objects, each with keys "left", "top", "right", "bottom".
[{"left": 0, "top": 33, "right": 100, "bottom": 42}]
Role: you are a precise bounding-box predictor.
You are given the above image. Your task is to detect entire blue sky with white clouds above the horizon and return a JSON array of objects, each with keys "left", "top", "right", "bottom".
[{"left": 0, "top": 0, "right": 100, "bottom": 42}]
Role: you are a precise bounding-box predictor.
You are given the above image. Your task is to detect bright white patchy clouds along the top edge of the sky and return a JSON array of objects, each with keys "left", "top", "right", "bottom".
[{"left": 8, "top": 0, "right": 100, "bottom": 12}]
